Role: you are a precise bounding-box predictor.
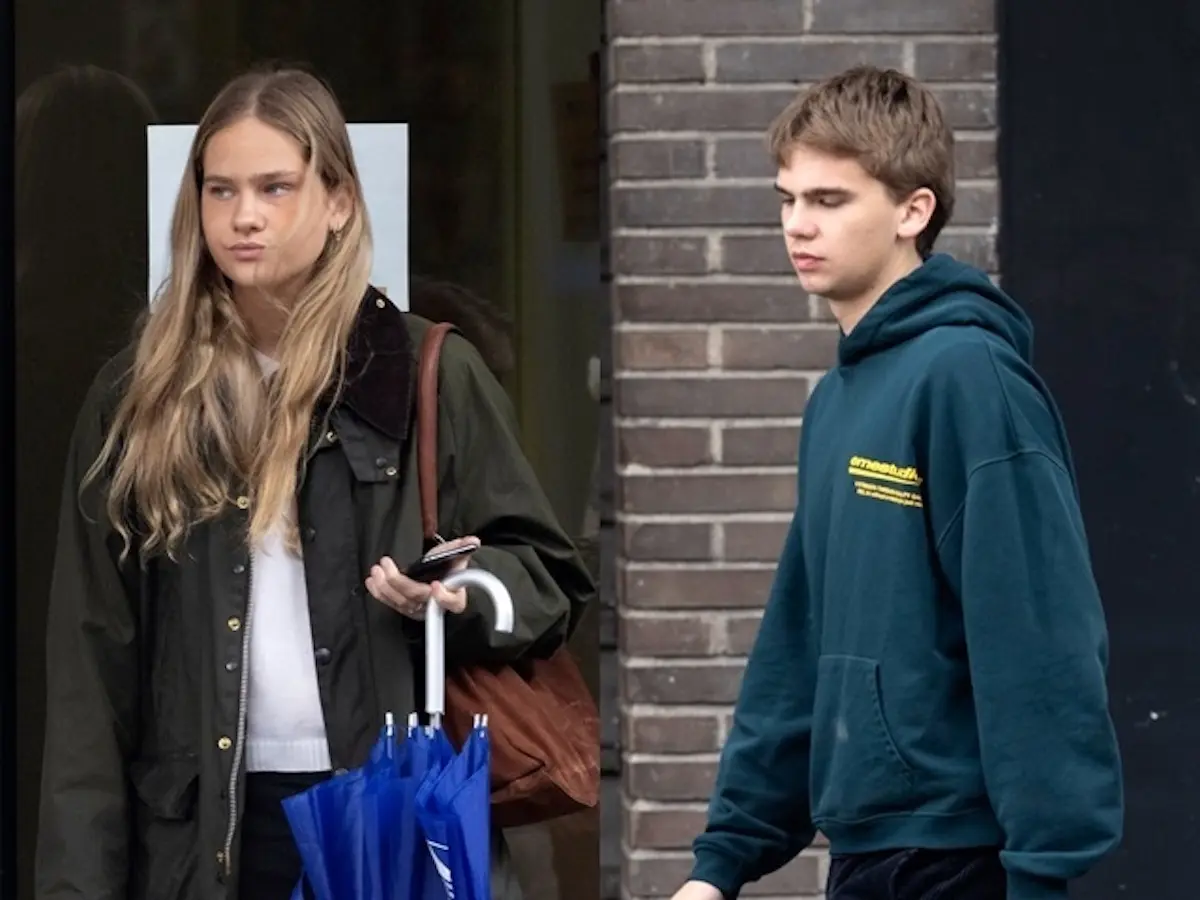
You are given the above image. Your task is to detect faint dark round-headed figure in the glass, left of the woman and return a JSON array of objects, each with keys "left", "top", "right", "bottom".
[{"left": 13, "top": 65, "right": 158, "bottom": 898}]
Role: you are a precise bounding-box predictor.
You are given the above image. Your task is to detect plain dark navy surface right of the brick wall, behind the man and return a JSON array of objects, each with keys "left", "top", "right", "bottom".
[{"left": 1001, "top": 0, "right": 1200, "bottom": 900}]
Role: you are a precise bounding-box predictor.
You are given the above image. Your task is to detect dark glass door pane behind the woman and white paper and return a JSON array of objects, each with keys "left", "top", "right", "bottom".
[{"left": 14, "top": 0, "right": 530, "bottom": 900}]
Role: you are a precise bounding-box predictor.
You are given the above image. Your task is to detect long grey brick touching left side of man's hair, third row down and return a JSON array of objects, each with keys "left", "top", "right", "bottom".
[{"left": 608, "top": 88, "right": 796, "bottom": 132}]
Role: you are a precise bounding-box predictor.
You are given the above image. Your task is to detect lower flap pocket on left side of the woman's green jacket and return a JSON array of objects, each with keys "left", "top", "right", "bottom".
[{"left": 130, "top": 755, "right": 200, "bottom": 900}]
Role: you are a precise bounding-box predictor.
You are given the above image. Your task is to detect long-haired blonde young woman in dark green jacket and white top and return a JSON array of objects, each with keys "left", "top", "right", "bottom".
[{"left": 37, "top": 70, "right": 585, "bottom": 900}]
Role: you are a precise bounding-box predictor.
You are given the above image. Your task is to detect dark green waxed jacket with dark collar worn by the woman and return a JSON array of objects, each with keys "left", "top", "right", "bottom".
[{"left": 36, "top": 289, "right": 594, "bottom": 900}]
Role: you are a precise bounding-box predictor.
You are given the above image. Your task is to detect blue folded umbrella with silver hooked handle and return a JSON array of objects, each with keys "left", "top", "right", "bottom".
[{"left": 283, "top": 569, "right": 512, "bottom": 900}]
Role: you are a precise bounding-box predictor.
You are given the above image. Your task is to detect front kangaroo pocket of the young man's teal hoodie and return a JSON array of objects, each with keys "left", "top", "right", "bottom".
[{"left": 811, "top": 656, "right": 913, "bottom": 822}]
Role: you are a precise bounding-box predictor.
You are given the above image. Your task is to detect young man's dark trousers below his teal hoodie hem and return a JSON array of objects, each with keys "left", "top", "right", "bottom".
[{"left": 826, "top": 847, "right": 1008, "bottom": 900}]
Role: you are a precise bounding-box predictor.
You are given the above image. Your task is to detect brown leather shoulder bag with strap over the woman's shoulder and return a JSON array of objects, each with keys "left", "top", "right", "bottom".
[{"left": 416, "top": 323, "right": 600, "bottom": 828}]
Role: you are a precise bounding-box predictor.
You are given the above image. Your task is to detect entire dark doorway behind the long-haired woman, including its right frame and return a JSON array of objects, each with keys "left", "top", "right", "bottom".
[{"left": 8, "top": 0, "right": 606, "bottom": 900}]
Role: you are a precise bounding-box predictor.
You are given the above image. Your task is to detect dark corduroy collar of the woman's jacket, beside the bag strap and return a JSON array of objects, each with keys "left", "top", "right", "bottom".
[{"left": 340, "top": 287, "right": 416, "bottom": 440}]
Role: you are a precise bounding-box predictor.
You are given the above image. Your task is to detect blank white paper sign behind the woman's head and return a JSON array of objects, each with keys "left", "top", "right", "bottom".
[{"left": 146, "top": 122, "right": 408, "bottom": 310}]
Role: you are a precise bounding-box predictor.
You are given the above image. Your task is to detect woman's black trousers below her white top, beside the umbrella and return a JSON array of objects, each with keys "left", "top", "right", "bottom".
[{"left": 238, "top": 772, "right": 330, "bottom": 900}]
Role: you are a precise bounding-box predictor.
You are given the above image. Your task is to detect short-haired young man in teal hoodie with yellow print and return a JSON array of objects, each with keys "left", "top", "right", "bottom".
[{"left": 676, "top": 68, "right": 1123, "bottom": 900}]
